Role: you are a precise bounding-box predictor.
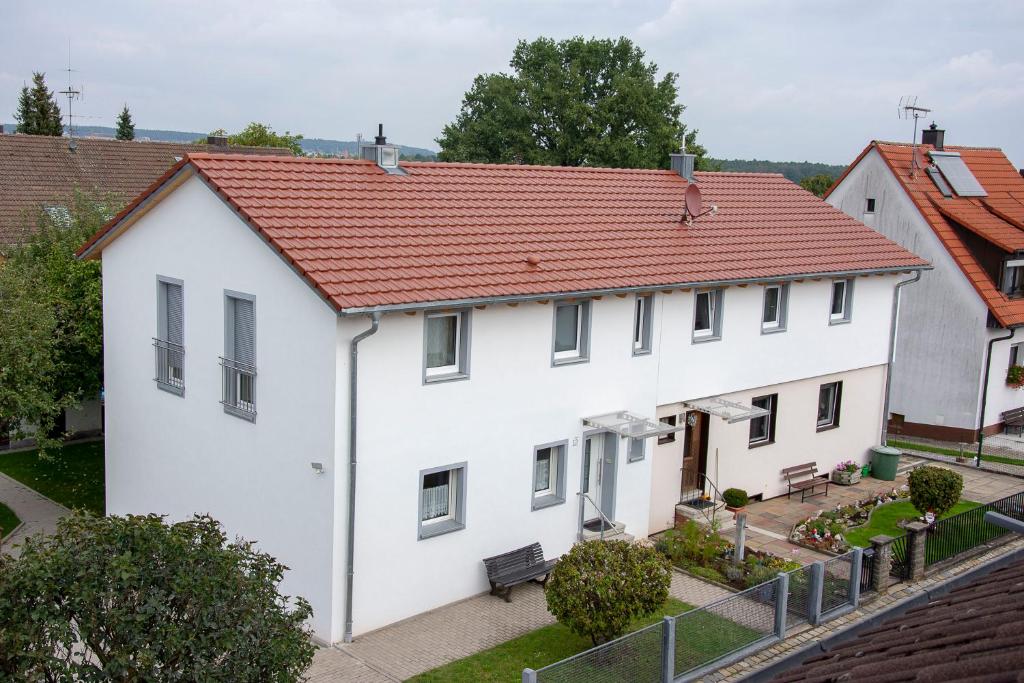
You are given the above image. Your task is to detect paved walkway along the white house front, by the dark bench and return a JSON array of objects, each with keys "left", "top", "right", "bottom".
[{"left": 306, "top": 571, "right": 731, "bottom": 683}]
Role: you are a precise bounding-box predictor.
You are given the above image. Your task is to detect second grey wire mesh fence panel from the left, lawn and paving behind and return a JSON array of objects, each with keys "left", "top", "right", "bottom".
[{"left": 675, "top": 580, "right": 778, "bottom": 676}]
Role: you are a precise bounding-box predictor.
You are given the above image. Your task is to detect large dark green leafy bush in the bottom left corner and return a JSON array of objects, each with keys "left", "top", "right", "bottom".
[{"left": 0, "top": 513, "right": 314, "bottom": 682}]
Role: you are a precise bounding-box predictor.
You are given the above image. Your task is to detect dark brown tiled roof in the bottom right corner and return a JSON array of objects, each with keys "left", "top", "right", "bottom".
[{"left": 772, "top": 561, "right": 1024, "bottom": 683}]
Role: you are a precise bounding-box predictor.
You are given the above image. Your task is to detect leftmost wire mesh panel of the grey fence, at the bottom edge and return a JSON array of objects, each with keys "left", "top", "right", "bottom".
[{"left": 537, "top": 624, "right": 663, "bottom": 683}]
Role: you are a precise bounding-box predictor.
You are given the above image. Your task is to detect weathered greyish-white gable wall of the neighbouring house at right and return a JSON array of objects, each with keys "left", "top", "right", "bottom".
[{"left": 827, "top": 150, "right": 987, "bottom": 429}]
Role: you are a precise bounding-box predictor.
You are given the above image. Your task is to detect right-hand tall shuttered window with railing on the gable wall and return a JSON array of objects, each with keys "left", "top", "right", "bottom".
[{"left": 220, "top": 292, "right": 256, "bottom": 420}]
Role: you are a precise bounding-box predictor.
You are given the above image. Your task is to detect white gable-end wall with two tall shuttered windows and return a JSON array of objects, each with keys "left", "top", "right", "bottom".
[{"left": 103, "top": 178, "right": 337, "bottom": 639}]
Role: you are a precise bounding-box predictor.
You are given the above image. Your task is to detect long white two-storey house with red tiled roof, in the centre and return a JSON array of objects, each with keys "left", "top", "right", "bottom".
[{"left": 82, "top": 140, "right": 927, "bottom": 641}]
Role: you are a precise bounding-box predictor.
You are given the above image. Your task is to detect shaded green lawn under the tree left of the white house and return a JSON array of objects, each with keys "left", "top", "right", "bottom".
[{"left": 0, "top": 441, "right": 103, "bottom": 515}]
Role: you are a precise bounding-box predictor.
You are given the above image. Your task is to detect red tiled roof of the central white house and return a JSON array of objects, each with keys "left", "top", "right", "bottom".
[{"left": 83, "top": 154, "right": 927, "bottom": 310}]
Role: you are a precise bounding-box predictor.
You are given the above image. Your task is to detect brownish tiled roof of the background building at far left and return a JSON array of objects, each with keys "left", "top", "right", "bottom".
[{"left": 0, "top": 135, "right": 291, "bottom": 249}]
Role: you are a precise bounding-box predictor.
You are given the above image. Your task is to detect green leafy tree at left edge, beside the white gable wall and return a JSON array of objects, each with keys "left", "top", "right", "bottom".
[{"left": 0, "top": 193, "right": 109, "bottom": 447}]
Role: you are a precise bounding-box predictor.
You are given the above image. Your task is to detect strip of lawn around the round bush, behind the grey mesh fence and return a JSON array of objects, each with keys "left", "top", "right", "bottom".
[{"left": 410, "top": 598, "right": 761, "bottom": 683}]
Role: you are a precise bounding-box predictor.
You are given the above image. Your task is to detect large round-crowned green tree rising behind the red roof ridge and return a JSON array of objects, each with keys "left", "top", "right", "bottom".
[{"left": 437, "top": 37, "right": 706, "bottom": 168}]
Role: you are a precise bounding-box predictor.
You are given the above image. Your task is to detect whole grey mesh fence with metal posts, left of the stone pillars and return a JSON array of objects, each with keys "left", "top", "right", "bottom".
[{"left": 522, "top": 548, "right": 873, "bottom": 683}]
